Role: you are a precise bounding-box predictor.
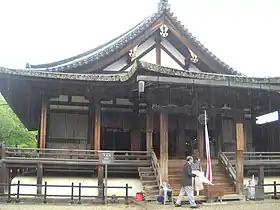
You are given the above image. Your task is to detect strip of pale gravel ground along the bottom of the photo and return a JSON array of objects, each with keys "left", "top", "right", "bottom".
[{"left": 0, "top": 201, "right": 280, "bottom": 210}]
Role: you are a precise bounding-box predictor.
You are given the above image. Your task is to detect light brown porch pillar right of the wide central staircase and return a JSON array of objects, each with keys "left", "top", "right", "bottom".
[{"left": 236, "top": 122, "right": 244, "bottom": 194}]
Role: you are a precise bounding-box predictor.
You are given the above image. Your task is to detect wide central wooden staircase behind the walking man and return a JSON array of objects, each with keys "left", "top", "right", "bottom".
[{"left": 168, "top": 160, "right": 236, "bottom": 196}]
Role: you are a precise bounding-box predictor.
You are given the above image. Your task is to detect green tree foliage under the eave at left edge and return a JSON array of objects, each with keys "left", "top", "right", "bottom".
[{"left": 0, "top": 95, "right": 37, "bottom": 148}]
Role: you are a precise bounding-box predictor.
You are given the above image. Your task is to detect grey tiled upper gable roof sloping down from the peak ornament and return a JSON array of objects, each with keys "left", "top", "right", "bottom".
[{"left": 24, "top": 0, "right": 243, "bottom": 75}]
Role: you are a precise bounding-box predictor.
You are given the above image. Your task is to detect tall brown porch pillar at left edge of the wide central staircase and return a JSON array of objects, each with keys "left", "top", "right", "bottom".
[{"left": 160, "top": 112, "right": 168, "bottom": 180}]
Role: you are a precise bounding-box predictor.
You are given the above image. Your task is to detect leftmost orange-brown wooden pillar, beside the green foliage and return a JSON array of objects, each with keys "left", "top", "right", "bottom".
[{"left": 40, "top": 98, "right": 48, "bottom": 149}]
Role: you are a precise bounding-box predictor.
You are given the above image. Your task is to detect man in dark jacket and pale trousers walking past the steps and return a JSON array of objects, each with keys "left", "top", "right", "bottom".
[{"left": 175, "top": 156, "right": 198, "bottom": 208}]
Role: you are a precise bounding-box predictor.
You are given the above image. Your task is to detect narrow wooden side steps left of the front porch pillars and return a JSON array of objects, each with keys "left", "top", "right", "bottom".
[{"left": 138, "top": 167, "right": 159, "bottom": 201}]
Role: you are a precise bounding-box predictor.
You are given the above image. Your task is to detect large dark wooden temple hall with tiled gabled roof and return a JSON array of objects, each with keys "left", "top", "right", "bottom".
[{"left": 0, "top": 0, "right": 280, "bottom": 199}]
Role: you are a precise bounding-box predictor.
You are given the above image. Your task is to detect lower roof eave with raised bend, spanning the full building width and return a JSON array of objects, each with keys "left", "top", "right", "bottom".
[{"left": 0, "top": 60, "right": 280, "bottom": 91}]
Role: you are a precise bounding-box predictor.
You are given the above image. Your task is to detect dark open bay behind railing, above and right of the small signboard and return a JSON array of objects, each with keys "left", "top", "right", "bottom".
[{"left": 100, "top": 127, "right": 131, "bottom": 151}]
